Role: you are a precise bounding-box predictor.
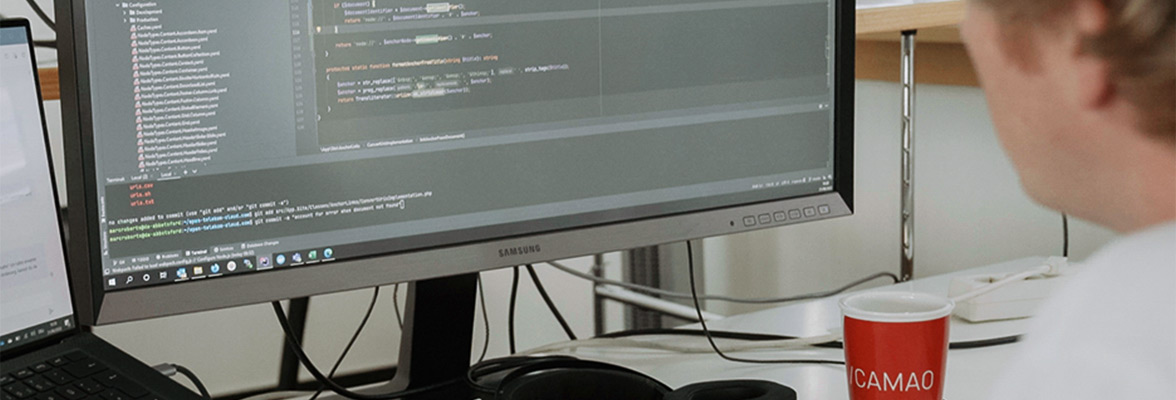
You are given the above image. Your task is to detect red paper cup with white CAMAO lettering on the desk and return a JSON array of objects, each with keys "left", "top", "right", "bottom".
[{"left": 841, "top": 292, "right": 955, "bottom": 400}]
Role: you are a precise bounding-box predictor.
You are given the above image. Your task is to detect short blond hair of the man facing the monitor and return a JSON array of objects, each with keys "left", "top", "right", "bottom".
[{"left": 975, "top": 0, "right": 1176, "bottom": 142}]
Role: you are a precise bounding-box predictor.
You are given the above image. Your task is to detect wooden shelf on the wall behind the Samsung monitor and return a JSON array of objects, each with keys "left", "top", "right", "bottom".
[{"left": 39, "top": 0, "right": 976, "bottom": 100}]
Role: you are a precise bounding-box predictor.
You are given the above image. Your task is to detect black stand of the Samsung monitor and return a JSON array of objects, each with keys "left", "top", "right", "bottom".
[{"left": 320, "top": 273, "right": 477, "bottom": 400}]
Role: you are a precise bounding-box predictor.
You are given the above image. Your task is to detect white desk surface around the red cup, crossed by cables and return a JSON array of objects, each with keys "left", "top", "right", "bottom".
[{"left": 533, "top": 258, "right": 1044, "bottom": 400}]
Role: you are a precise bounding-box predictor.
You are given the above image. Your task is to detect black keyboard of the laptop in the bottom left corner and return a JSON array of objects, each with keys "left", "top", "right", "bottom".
[{"left": 0, "top": 352, "right": 159, "bottom": 400}]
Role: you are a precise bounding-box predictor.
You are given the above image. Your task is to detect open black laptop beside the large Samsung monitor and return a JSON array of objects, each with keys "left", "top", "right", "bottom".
[{"left": 0, "top": 19, "right": 201, "bottom": 400}]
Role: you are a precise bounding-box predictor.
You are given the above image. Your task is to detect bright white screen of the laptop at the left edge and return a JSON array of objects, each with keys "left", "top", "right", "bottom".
[{"left": 0, "top": 24, "right": 74, "bottom": 349}]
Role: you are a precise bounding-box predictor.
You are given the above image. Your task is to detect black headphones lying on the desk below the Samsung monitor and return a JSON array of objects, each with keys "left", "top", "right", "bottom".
[{"left": 466, "top": 355, "right": 796, "bottom": 400}]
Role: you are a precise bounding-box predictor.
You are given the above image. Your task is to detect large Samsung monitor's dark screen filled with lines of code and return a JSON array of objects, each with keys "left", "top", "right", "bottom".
[{"left": 64, "top": 0, "right": 851, "bottom": 322}]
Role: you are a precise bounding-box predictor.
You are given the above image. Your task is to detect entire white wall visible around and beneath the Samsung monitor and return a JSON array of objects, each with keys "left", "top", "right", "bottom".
[{"left": 0, "top": 0, "right": 1114, "bottom": 394}]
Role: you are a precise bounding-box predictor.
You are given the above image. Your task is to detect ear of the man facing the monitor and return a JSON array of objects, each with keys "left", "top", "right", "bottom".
[{"left": 1065, "top": 0, "right": 1115, "bottom": 108}]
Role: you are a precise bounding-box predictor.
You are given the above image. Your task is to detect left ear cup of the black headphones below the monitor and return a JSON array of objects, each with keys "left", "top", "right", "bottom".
[{"left": 496, "top": 367, "right": 669, "bottom": 400}]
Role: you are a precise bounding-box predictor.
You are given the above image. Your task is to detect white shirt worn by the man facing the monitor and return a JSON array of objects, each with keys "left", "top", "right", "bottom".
[{"left": 991, "top": 222, "right": 1176, "bottom": 400}]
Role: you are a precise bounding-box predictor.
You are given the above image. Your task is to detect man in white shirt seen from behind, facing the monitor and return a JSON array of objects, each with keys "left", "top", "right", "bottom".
[{"left": 961, "top": 0, "right": 1176, "bottom": 400}]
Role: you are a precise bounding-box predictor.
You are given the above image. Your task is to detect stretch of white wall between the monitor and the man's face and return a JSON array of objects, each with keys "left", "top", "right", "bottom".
[{"left": 706, "top": 81, "right": 1114, "bottom": 313}]
